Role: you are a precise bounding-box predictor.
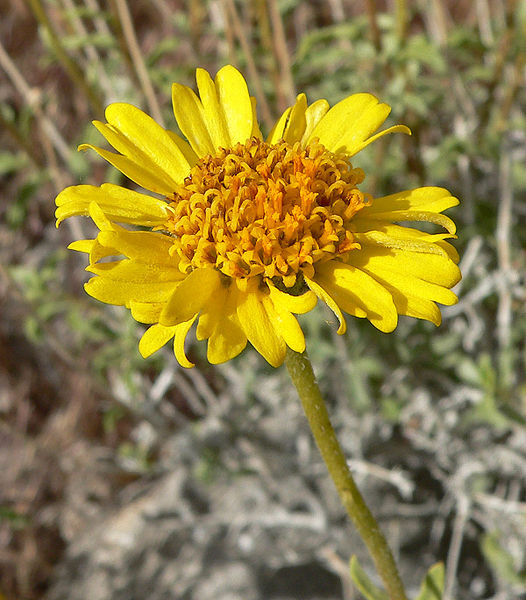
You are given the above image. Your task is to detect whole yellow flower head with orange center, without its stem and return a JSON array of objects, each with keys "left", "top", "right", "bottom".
[{"left": 56, "top": 66, "right": 460, "bottom": 367}]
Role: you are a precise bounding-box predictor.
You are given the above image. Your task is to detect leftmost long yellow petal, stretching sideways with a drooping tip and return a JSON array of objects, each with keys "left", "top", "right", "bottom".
[{"left": 55, "top": 183, "right": 169, "bottom": 227}]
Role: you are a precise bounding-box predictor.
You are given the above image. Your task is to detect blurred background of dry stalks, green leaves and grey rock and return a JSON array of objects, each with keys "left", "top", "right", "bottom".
[{"left": 0, "top": 0, "right": 526, "bottom": 600}]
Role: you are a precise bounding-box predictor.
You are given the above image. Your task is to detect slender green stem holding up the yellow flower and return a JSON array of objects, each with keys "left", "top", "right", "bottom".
[{"left": 285, "top": 349, "right": 407, "bottom": 600}]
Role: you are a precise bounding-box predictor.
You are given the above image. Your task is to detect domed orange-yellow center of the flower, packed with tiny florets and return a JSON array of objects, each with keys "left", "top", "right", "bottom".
[{"left": 162, "top": 138, "right": 367, "bottom": 287}]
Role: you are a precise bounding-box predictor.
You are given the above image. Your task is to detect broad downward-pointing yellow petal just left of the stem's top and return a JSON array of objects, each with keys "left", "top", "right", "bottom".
[{"left": 236, "top": 281, "right": 287, "bottom": 367}]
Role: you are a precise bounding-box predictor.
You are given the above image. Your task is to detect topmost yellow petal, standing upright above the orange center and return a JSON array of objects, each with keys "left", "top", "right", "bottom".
[{"left": 215, "top": 65, "right": 253, "bottom": 146}]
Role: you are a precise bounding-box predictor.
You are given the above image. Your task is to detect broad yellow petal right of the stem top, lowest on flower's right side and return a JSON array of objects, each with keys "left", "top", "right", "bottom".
[{"left": 316, "top": 260, "right": 398, "bottom": 333}]
